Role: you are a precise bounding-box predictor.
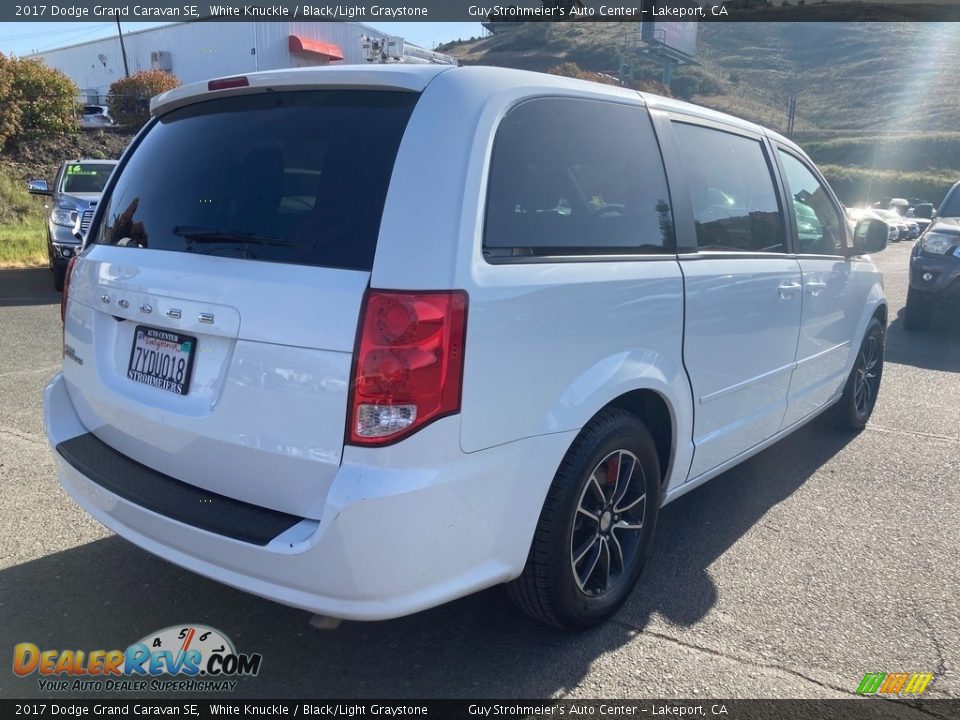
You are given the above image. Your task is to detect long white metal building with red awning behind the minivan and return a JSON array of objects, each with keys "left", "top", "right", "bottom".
[{"left": 30, "top": 21, "right": 457, "bottom": 105}]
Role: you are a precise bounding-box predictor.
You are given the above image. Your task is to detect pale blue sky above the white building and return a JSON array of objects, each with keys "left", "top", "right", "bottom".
[{"left": 0, "top": 22, "right": 483, "bottom": 55}]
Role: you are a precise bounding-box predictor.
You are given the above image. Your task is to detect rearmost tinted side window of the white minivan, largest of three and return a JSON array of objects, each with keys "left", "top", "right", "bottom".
[{"left": 483, "top": 98, "right": 675, "bottom": 258}]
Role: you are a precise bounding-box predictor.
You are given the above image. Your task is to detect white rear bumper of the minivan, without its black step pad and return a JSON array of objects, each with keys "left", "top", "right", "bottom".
[{"left": 44, "top": 375, "right": 575, "bottom": 620}]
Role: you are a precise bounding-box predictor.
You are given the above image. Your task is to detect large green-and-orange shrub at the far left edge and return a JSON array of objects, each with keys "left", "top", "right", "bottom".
[{"left": 0, "top": 53, "right": 77, "bottom": 147}]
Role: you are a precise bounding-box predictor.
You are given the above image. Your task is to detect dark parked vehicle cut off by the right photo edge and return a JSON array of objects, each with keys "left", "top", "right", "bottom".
[{"left": 903, "top": 182, "right": 960, "bottom": 330}]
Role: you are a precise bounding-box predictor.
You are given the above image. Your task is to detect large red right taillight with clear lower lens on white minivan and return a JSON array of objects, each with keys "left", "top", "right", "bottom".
[{"left": 347, "top": 290, "right": 467, "bottom": 445}]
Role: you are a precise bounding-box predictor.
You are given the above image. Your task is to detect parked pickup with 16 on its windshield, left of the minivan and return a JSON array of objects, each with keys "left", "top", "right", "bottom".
[{"left": 27, "top": 159, "right": 117, "bottom": 290}]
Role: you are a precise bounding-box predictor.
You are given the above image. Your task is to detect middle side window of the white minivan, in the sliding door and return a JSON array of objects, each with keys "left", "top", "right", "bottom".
[{"left": 674, "top": 122, "right": 786, "bottom": 252}]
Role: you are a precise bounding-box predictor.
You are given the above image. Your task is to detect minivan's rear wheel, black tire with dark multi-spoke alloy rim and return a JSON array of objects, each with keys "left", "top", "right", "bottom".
[{"left": 508, "top": 409, "right": 660, "bottom": 630}]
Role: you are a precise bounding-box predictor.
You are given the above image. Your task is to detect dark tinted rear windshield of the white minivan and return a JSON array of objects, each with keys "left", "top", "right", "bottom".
[{"left": 96, "top": 90, "right": 418, "bottom": 270}]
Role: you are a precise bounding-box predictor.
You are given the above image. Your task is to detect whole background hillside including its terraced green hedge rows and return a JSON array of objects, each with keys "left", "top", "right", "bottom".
[{"left": 443, "top": 22, "right": 960, "bottom": 203}]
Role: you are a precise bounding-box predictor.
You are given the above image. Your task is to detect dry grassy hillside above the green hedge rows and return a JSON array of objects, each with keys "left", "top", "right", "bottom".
[{"left": 442, "top": 22, "right": 960, "bottom": 133}]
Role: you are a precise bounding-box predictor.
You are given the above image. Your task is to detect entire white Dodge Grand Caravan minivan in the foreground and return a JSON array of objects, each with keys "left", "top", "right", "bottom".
[{"left": 44, "top": 66, "right": 887, "bottom": 628}]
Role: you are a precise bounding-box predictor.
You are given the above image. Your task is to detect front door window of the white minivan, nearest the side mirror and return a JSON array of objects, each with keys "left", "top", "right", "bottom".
[{"left": 779, "top": 150, "right": 846, "bottom": 255}]
